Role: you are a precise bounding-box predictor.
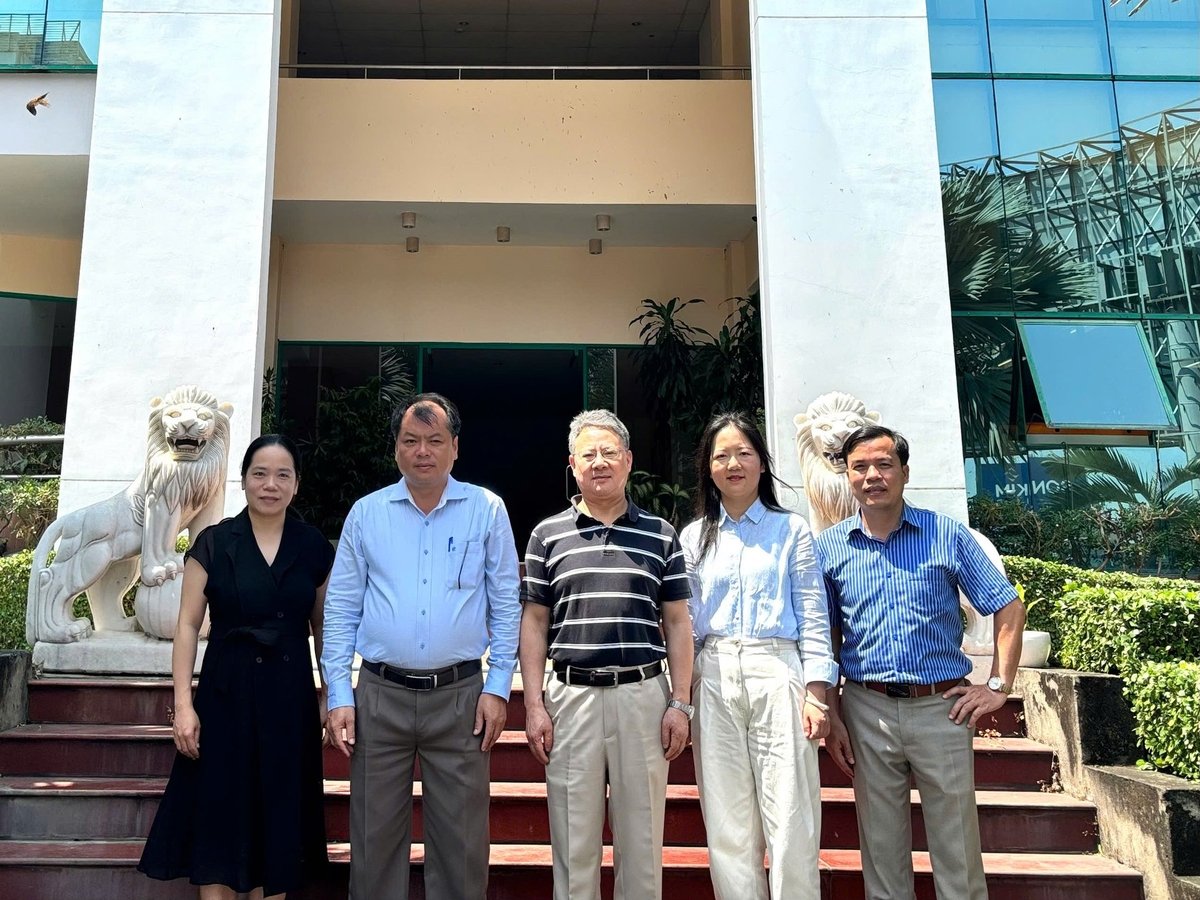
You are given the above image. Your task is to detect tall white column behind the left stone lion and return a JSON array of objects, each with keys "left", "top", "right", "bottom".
[{"left": 60, "top": 0, "right": 280, "bottom": 512}]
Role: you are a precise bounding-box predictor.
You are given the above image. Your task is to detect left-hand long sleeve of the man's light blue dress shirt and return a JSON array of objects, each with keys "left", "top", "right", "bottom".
[{"left": 320, "top": 504, "right": 367, "bottom": 709}]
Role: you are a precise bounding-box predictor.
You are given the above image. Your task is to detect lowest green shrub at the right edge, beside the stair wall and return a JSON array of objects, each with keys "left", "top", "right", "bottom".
[{"left": 1126, "top": 662, "right": 1200, "bottom": 781}]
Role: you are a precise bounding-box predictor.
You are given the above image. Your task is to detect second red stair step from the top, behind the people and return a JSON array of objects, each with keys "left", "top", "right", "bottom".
[{"left": 0, "top": 724, "right": 1054, "bottom": 791}]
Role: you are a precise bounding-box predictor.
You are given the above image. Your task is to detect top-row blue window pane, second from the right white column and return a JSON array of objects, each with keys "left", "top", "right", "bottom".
[{"left": 988, "top": 0, "right": 1110, "bottom": 74}]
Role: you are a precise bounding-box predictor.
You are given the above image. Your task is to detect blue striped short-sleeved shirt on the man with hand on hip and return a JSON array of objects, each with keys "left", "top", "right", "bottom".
[{"left": 817, "top": 504, "right": 1016, "bottom": 684}]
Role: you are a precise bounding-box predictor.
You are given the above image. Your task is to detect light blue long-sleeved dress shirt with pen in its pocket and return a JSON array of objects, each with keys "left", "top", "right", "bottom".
[{"left": 320, "top": 478, "right": 521, "bottom": 709}]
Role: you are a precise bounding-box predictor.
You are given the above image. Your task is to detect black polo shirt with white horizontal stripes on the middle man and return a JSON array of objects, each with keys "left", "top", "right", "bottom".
[{"left": 521, "top": 502, "right": 691, "bottom": 668}]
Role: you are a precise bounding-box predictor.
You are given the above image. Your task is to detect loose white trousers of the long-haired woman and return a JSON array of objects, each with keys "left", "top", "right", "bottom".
[{"left": 691, "top": 637, "right": 821, "bottom": 900}]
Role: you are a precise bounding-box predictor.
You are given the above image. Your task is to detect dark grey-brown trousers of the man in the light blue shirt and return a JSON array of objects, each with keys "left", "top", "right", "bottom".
[{"left": 350, "top": 668, "right": 491, "bottom": 900}]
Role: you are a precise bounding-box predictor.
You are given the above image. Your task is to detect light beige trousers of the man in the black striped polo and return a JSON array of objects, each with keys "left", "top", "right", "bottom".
[{"left": 545, "top": 674, "right": 671, "bottom": 900}]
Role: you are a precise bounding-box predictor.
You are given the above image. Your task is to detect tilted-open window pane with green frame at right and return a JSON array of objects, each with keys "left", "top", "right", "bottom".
[{"left": 1018, "top": 320, "right": 1176, "bottom": 430}]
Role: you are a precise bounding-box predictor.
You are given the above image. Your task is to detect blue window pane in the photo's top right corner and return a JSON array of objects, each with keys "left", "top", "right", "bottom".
[{"left": 1108, "top": 0, "right": 1200, "bottom": 76}]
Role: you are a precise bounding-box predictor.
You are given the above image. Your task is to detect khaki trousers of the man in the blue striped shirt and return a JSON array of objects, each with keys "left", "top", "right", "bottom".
[{"left": 841, "top": 683, "right": 988, "bottom": 900}]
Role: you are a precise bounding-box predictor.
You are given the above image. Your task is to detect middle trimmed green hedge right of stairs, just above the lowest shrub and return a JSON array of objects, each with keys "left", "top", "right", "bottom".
[{"left": 1054, "top": 587, "right": 1200, "bottom": 676}]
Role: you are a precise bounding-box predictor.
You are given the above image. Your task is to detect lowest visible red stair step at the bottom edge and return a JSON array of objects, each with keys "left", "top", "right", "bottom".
[{"left": 0, "top": 841, "right": 1142, "bottom": 900}]
